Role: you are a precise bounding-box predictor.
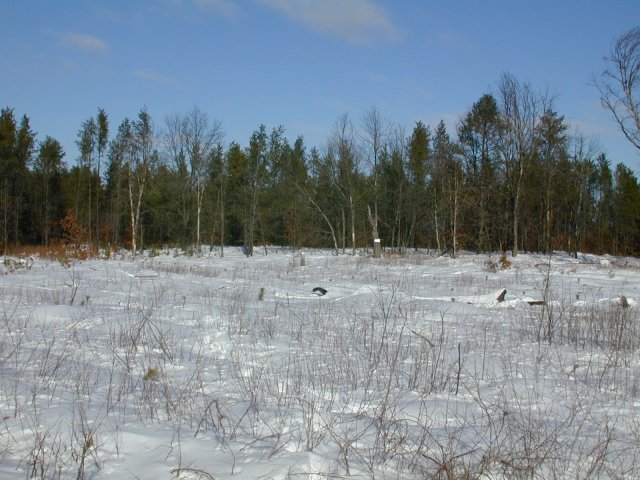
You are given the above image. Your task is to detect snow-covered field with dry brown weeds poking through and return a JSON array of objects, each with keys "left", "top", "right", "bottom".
[{"left": 0, "top": 248, "right": 640, "bottom": 479}]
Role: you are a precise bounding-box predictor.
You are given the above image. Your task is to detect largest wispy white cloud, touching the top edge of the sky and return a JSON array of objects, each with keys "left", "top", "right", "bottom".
[{"left": 258, "top": 0, "right": 402, "bottom": 44}]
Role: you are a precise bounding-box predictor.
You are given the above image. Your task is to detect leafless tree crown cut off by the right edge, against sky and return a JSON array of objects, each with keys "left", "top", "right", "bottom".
[{"left": 594, "top": 27, "right": 640, "bottom": 150}]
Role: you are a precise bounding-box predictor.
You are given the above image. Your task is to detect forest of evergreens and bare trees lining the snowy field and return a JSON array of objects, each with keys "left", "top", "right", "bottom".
[{"left": 0, "top": 69, "right": 640, "bottom": 256}]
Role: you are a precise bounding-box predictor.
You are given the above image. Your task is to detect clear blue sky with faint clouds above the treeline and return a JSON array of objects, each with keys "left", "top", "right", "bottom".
[{"left": 0, "top": 0, "right": 640, "bottom": 172}]
